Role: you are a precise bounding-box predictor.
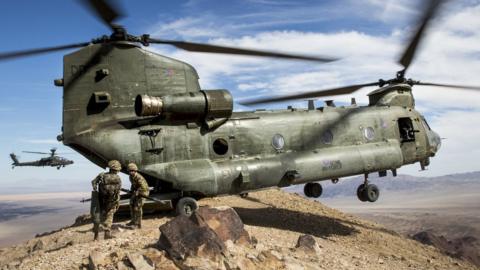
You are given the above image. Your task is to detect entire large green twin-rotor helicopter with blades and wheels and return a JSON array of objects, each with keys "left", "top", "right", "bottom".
[{"left": 0, "top": 0, "right": 480, "bottom": 214}]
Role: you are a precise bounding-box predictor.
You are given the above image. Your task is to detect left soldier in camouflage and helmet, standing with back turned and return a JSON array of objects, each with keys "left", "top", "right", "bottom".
[{"left": 92, "top": 160, "right": 122, "bottom": 240}]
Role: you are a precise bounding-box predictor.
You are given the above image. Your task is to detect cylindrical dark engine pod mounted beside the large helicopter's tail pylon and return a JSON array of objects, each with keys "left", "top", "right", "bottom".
[{"left": 135, "top": 89, "right": 233, "bottom": 119}]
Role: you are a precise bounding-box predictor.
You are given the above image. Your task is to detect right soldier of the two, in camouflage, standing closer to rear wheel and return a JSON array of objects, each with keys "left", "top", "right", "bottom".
[{"left": 127, "top": 163, "right": 149, "bottom": 228}]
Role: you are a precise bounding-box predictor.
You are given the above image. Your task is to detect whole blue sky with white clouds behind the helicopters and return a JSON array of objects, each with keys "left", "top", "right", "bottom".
[{"left": 0, "top": 0, "right": 480, "bottom": 193}]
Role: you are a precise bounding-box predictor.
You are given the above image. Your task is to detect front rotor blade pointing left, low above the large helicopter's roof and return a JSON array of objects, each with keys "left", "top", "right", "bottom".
[{"left": 239, "top": 82, "right": 378, "bottom": 105}]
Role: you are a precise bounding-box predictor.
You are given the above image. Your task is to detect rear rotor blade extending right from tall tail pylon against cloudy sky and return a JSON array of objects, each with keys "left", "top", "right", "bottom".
[{"left": 147, "top": 38, "right": 338, "bottom": 62}]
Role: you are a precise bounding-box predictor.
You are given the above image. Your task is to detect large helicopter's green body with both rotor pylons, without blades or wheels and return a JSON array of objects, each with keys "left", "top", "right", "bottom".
[{"left": 60, "top": 43, "right": 440, "bottom": 197}]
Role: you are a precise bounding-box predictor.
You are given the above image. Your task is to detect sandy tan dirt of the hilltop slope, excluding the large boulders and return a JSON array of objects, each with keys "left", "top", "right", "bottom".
[{"left": 0, "top": 189, "right": 476, "bottom": 269}]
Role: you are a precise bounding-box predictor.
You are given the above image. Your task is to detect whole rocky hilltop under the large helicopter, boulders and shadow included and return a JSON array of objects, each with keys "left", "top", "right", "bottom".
[{"left": 0, "top": 189, "right": 475, "bottom": 270}]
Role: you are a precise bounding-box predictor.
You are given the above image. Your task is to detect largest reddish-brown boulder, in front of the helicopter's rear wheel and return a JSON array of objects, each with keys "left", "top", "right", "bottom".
[{"left": 158, "top": 207, "right": 250, "bottom": 260}]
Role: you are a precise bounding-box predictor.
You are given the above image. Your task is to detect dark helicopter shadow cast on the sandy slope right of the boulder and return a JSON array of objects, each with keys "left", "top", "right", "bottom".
[{"left": 234, "top": 207, "right": 358, "bottom": 237}]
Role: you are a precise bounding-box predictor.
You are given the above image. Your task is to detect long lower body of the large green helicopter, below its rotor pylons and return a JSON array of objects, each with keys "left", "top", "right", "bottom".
[{"left": 66, "top": 101, "right": 438, "bottom": 196}]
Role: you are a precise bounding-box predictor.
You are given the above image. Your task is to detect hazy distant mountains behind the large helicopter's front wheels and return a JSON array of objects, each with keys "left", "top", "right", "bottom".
[{"left": 285, "top": 171, "right": 480, "bottom": 198}]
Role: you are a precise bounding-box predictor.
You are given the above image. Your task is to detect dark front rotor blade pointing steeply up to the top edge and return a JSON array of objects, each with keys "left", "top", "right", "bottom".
[{"left": 398, "top": 0, "right": 442, "bottom": 72}]
